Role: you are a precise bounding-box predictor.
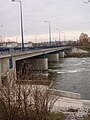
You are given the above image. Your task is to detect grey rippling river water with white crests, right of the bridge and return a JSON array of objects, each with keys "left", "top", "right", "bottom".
[{"left": 49, "top": 58, "right": 90, "bottom": 99}]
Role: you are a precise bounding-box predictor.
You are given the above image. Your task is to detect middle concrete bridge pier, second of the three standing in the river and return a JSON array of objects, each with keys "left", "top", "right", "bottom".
[{"left": 48, "top": 51, "right": 59, "bottom": 62}]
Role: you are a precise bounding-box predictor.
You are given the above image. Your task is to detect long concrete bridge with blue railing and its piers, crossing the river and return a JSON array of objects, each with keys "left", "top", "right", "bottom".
[{"left": 0, "top": 46, "right": 71, "bottom": 85}]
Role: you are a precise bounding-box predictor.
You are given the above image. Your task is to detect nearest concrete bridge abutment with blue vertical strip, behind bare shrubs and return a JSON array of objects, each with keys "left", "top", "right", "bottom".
[{"left": 0, "top": 56, "right": 16, "bottom": 86}]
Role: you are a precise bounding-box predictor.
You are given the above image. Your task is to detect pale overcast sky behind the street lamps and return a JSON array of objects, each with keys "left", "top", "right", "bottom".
[{"left": 0, "top": 0, "right": 90, "bottom": 40}]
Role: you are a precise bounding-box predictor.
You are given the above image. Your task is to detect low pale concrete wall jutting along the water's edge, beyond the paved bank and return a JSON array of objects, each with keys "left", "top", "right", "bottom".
[{"left": 48, "top": 89, "right": 81, "bottom": 100}]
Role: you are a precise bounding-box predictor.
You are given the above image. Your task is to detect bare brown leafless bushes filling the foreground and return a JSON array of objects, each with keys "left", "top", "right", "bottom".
[{"left": 0, "top": 71, "right": 58, "bottom": 120}]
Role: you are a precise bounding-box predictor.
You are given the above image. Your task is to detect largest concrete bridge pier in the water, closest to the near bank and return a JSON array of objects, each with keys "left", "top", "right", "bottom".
[{"left": 31, "top": 54, "right": 48, "bottom": 71}]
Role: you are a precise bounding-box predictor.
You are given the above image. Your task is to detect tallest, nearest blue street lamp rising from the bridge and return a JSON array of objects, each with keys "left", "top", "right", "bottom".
[{"left": 12, "top": 0, "right": 24, "bottom": 51}]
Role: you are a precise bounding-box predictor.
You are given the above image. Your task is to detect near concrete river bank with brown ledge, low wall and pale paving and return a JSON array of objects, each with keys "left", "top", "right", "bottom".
[{"left": 17, "top": 80, "right": 90, "bottom": 112}]
